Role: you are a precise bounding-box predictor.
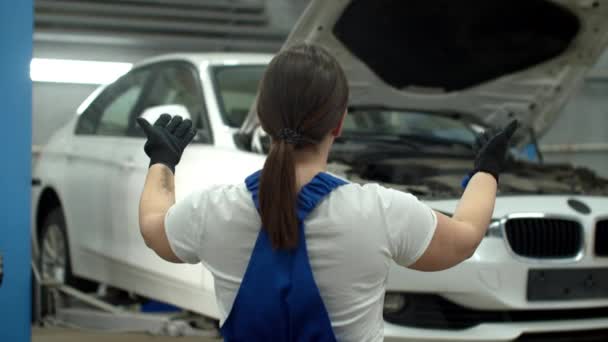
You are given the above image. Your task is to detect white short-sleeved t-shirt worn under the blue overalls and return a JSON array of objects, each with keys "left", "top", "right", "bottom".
[{"left": 165, "top": 182, "right": 437, "bottom": 341}]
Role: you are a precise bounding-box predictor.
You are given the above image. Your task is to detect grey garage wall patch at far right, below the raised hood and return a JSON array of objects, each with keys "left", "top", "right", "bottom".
[{"left": 540, "top": 51, "right": 608, "bottom": 177}]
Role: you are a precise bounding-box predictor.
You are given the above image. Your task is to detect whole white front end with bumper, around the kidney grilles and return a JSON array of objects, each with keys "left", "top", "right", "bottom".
[{"left": 385, "top": 196, "right": 608, "bottom": 341}]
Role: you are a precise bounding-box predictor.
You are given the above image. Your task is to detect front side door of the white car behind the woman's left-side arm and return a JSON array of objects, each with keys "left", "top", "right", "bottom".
[{"left": 112, "top": 62, "right": 213, "bottom": 289}]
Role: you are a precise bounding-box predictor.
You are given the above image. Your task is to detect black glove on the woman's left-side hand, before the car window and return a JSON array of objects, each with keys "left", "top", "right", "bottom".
[{"left": 137, "top": 114, "right": 196, "bottom": 173}]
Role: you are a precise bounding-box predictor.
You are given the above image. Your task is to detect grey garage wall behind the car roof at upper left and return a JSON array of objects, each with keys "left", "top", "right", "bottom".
[{"left": 32, "top": 0, "right": 296, "bottom": 145}]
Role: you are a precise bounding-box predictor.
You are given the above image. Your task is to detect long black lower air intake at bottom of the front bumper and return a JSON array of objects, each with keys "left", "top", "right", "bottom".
[{"left": 384, "top": 294, "right": 608, "bottom": 330}]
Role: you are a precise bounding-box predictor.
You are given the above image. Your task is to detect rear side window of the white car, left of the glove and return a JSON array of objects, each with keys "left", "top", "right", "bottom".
[{"left": 76, "top": 69, "right": 150, "bottom": 136}]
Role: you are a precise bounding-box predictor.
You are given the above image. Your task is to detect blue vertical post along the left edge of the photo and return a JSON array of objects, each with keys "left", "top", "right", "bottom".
[{"left": 0, "top": 0, "right": 34, "bottom": 342}]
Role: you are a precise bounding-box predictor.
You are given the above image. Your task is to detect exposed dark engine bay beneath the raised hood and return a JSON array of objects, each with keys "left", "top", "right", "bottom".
[{"left": 328, "top": 157, "right": 608, "bottom": 199}]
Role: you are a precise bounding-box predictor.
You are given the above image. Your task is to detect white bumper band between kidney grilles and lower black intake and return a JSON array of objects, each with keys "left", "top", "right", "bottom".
[{"left": 387, "top": 237, "right": 608, "bottom": 310}]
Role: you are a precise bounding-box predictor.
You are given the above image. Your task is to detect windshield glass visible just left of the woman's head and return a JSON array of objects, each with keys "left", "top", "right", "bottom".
[{"left": 212, "top": 65, "right": 266, "bottom": 128}]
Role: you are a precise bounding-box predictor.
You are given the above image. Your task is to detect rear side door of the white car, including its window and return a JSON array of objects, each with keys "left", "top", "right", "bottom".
[{"left": 63, "top": 69, "right": 150, "bottom": 272}]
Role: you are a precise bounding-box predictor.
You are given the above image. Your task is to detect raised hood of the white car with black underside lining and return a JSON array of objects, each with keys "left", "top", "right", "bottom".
[{"left": 241, "top": 0, "right": 608, "bottom": 142}]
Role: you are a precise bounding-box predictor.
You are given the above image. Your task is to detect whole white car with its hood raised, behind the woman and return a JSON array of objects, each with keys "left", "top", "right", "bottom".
[{"left": 32, "top": 0, "right": 608, "bottom": 341}]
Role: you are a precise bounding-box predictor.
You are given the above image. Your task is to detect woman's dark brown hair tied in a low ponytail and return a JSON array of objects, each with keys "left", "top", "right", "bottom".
[{"left": 257, "top": 45, "right": 348, "bottom": 249}]
